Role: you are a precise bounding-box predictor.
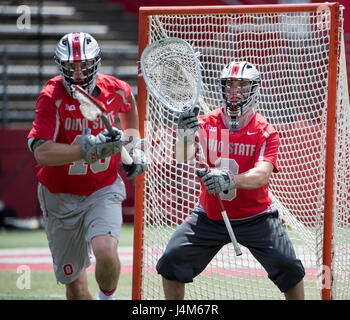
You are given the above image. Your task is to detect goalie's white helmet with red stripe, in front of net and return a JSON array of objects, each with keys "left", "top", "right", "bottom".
[{"left": 220, "top": 61, "right": 260, "bottom": 117}]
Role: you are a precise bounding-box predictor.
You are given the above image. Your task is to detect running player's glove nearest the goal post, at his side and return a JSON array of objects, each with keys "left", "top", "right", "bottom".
[{"left": 120, "top": 137, "right": 147, "bottom": 180}]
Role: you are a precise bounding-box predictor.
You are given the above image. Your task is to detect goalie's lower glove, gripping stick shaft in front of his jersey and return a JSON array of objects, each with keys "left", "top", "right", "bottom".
[{"left": 197, "top": 169, "right": 236, "bottom": 194}]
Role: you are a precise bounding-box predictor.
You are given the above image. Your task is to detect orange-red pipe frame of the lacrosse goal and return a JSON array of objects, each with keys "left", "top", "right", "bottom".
[{"left": 132, "top": 2, "right": 340, "bottom": 300}]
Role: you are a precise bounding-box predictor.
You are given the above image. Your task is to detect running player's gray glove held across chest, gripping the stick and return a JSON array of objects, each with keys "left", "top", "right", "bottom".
[{"left": 81, "top": 127, "right": 123, "bottom": 163}]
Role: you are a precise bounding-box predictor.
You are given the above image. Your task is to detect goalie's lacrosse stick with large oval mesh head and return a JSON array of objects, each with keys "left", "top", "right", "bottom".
[{"left": 141, "top": 38, "right": 242, "bottom": 256}]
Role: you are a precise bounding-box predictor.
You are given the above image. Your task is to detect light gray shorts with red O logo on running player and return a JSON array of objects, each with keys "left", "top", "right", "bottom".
[{"left": 38, "top": 178, "right": 125, "bottom": 284}]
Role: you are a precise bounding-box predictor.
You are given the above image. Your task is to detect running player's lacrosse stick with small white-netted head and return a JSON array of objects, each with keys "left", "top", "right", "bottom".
[{"left": 73, "top": 85, "right": 133, "bottom": 165}]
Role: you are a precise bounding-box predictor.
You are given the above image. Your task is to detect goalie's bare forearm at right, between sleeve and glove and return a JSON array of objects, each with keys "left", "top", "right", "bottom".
[{"left": 234, "top": 161, "right": 274, "bottom": 189}]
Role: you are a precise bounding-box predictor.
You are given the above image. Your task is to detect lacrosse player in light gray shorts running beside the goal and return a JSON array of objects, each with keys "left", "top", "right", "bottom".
[{"left": 28, "top": 32, "right": 146, "bottom": 300}]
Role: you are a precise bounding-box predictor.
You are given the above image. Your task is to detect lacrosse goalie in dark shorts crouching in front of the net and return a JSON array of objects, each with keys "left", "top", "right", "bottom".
[{"left": 157, "top": 61, "right": 305, "bottom": 299}]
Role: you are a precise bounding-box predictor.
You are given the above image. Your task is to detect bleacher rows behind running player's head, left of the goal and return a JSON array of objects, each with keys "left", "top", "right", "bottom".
[{"left": 0, "top": 0, "right": 138, "bottom": 125}]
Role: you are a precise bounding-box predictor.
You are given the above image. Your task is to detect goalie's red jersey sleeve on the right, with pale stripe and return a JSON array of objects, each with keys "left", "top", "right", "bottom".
[{"left": 256, "top": 131, "right": 279, "bottom": 172}]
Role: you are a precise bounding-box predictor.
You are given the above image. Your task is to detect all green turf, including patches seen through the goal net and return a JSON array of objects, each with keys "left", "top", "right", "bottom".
[{"left": 0, "top": 224, "right": 346, "bottom": 300}]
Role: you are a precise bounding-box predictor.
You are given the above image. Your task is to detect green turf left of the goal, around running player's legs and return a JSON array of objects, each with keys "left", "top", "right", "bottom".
[{"left": 0, "top": 224, "right": 133, "bottom": 300}]
